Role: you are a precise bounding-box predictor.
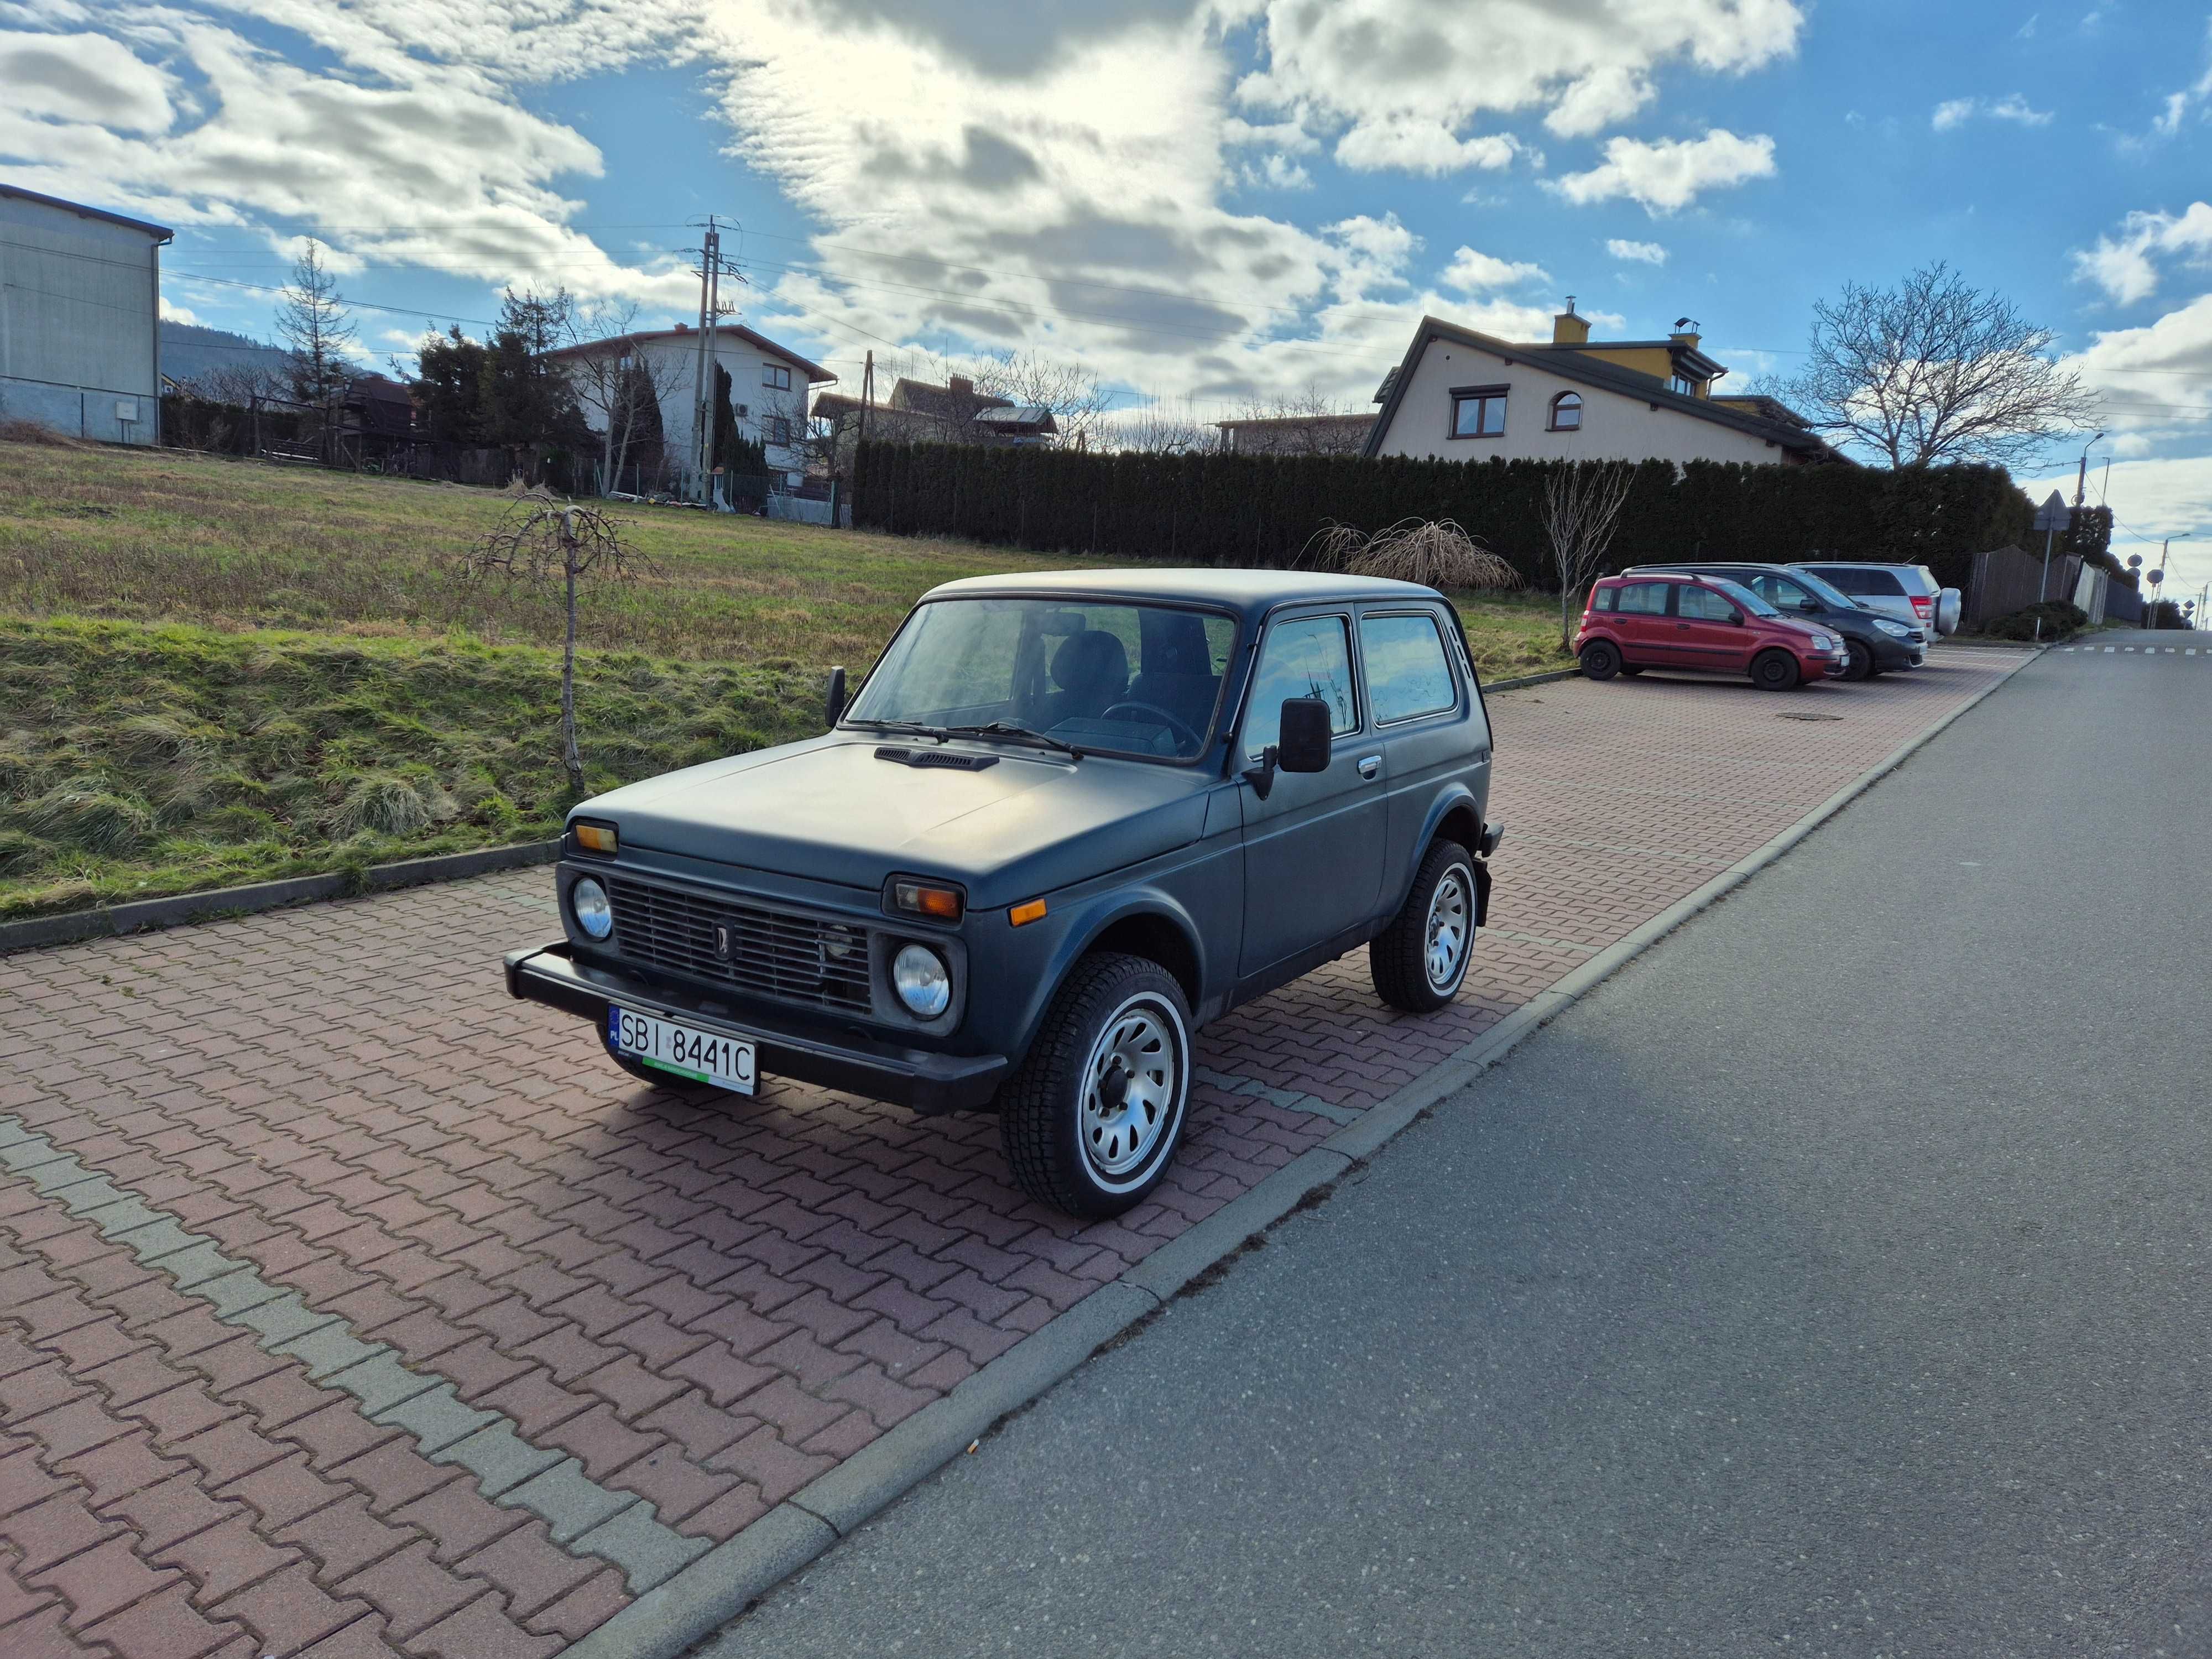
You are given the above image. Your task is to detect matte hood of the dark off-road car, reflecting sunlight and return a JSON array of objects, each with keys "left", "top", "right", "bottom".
[{"left": 575, "top": 732, "right": 1214, "bottom": 907}]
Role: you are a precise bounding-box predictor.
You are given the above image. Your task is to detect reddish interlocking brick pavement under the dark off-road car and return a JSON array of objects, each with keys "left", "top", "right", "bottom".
[{"left": 0, "top": 650, "right": 2020, "bottom": 1659}]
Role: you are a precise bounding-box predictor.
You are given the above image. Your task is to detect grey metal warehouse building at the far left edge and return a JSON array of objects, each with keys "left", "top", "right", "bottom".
[{"left": 0, "top": 184, "right": 173, "bottom": 445}]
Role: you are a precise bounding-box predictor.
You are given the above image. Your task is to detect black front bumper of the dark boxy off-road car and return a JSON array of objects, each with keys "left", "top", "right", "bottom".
[{"left": 504, "top": 940, "right": 1006, "bottom": 1113}]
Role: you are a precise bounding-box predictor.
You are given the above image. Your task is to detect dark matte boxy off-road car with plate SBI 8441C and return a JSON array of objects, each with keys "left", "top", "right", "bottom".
[{"left": 507, "top": 571, "right": 1504, "bottom": 1217}]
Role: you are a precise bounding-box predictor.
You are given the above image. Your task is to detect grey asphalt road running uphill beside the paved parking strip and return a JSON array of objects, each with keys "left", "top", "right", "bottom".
[{"left": 703, "top": 635, "right": 2212, "bottom": 1659}]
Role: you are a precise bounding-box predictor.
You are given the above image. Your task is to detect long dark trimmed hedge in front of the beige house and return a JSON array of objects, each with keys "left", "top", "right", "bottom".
[{"left": 854, "top": 442, "right": 2101, "bottom": 588}]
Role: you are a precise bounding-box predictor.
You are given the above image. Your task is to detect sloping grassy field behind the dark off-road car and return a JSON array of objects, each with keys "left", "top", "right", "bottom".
[{"left": 0, "top": 442, "right": 1564, "bottom": 918}]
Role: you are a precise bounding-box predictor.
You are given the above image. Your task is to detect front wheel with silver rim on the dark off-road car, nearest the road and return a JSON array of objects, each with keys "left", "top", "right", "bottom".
[{"left": 998, "top": 953, "right": 1192, "bottom": 1221}]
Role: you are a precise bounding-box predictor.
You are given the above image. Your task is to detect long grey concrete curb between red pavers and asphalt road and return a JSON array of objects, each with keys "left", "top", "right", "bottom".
[{"left": 584, "top": 661, "right": 2026, "bottom": 1659}]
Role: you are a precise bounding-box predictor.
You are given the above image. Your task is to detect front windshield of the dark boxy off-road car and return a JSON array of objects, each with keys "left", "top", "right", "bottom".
[{"left": 843, "top": 597, "right": 1237, "bottom": 761}]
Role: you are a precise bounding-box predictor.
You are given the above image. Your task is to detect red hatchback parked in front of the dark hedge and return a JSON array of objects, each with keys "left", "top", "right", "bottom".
[{"left": 1575, "top": 573, "right": 1849, "bottom": 690}]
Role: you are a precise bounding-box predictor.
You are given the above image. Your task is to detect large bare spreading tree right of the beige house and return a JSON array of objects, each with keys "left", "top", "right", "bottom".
[{"left": 1772, "top": 261, "right": 2097, "bottom": 467}]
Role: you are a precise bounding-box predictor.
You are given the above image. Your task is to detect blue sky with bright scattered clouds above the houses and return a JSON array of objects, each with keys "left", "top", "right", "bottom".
[{"left": 0, "top": 0, "right": 2212, "bottom": 588}]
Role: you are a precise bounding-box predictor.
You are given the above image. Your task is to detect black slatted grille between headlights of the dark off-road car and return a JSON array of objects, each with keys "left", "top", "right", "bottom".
[{"left": 606, "top": 876, "right": 872, "bottom": 1013}]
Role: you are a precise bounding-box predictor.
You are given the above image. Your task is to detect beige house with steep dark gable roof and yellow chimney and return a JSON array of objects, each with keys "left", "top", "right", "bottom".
[{"left": 1365, "top": 301, "right": 1843, "bottom": 467}]
